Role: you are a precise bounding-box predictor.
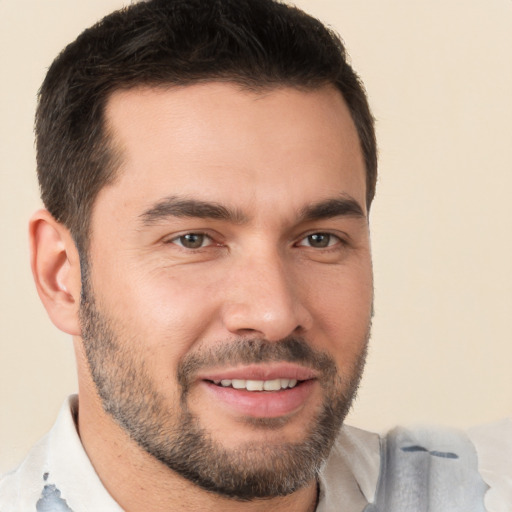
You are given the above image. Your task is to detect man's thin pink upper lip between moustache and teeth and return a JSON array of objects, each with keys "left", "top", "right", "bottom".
[{"left": 198, "top": 362, "right": 317, "bottom": 381}]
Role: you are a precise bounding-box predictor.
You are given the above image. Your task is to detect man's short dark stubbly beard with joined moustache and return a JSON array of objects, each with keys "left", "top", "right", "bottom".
[{"left": 80, "top": 280, "right": 369, "bottom": 501}]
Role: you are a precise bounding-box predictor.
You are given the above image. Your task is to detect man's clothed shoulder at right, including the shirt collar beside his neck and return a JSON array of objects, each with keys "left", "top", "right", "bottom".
[{"left": 319, "top": 419, "right": 512, "bottom": 512}]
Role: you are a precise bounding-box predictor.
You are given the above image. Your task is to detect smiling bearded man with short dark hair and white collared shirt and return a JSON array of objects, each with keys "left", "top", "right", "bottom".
[{"left": 0, "top": 0, "right": 510, "bottom": 512}]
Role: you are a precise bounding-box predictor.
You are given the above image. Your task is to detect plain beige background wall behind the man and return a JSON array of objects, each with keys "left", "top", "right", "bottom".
[{"left": 0, "top": 0, "right": 512, "bottom": 471}]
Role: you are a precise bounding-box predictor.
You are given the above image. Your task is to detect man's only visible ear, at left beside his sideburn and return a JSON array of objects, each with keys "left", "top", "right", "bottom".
[{"left": 29, "top": 210, "right": 81, "bottom": 336}]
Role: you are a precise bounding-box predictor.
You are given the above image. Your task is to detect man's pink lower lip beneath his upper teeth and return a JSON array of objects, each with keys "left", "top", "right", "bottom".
[{"left": 202, "top": 380, "right": 315, "bottom": 418}]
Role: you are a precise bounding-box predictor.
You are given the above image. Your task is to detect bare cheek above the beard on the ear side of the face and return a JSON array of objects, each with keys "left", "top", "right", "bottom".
[{"left": 90, "top": 264, "right": 224, "bottom": 362}]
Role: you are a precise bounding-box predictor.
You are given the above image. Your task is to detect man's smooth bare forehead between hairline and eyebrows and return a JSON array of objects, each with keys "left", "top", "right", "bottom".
[{"left": 98, "top": 83, "right": 365, "bottom": 219}]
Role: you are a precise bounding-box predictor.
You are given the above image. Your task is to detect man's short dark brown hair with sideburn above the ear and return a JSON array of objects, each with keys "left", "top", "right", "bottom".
[{"left": 36, "top": 0, "right": 377, "bottom": 249}]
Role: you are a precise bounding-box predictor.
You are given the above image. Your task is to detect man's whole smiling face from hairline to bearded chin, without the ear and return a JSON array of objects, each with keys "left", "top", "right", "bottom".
[{"left": 81, "top": 83, "right": 372, "bottom": 499}]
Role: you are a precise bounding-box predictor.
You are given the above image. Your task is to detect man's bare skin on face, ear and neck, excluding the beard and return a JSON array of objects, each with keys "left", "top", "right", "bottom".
[{"left": 31, "top": 83, "right": 373, "bottom": 512}]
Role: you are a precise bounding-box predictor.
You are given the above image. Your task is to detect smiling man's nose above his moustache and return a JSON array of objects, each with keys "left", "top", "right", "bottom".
[{"left": 222, "top": 253, "right": 313, "bottom": 341}]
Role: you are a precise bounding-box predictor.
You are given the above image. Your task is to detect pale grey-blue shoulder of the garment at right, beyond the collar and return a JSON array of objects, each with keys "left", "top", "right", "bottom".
[{"left": 377, "top": 420, "right": 512, "bottom": 512}]
